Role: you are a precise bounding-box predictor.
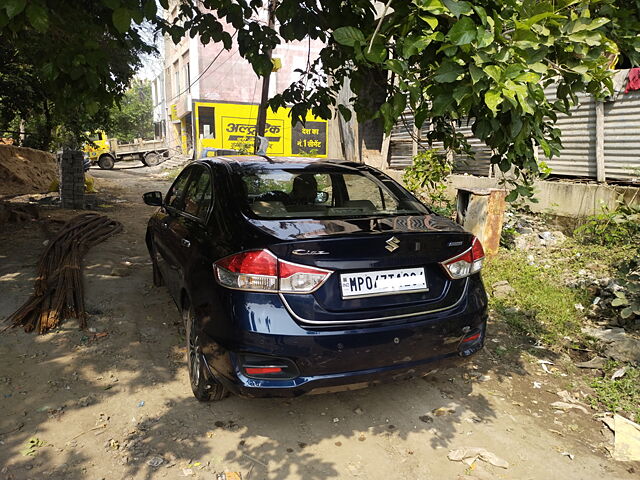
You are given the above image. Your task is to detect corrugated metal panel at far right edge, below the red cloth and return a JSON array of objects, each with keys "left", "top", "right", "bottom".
[{"left": 604, "top": 91, "right": 640, "bottom": 182}]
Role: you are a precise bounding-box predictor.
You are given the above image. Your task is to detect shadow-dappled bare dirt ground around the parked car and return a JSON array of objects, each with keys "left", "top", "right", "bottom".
[{"left": 0, "top": 159, "right": 640, "bottom": 480}]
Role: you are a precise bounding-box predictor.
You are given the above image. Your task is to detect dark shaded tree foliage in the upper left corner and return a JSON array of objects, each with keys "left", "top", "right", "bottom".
[{"left": 0, "top": 0, "right": 155, "bottom": 149}]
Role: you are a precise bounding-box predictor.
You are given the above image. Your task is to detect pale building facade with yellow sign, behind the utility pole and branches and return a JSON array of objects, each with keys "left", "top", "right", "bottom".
[{"left": 164, "top": 1, "right": 328, "bottom": 157}]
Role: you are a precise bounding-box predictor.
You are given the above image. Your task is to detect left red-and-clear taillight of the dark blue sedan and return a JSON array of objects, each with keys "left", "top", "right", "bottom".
[{"left": 213, "top": 250, "right": 331, "bottom": 293}]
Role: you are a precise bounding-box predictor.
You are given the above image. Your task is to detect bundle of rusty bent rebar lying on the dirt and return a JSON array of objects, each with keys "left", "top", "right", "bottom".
[{"left": 6, "top": 213, "right": 122, "bottom": 334}]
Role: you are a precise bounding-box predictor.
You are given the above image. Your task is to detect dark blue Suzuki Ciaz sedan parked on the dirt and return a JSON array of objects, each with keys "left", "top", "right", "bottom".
[{"left": 144, "top": 156, "right": 487, "bottom": 401}]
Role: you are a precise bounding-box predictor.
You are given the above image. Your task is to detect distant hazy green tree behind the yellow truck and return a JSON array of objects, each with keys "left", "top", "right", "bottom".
[{"left": 107, "top": 79, "right": 153, "bottom": 142}]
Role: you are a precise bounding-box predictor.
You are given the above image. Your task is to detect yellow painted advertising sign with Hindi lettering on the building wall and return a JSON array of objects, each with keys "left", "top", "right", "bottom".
[{"left": 193, "top": 101, "right": 327, "bottom": 157}]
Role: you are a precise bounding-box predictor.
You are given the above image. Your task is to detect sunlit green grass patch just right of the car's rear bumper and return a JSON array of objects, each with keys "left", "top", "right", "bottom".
[{"left": 483, "top": 250, "right": 590, "bottom": 346}]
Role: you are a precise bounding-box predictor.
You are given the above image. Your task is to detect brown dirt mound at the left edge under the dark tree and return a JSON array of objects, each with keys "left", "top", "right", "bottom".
[{"left": 0, "top": 145, "right": 58, "bottom": 195}]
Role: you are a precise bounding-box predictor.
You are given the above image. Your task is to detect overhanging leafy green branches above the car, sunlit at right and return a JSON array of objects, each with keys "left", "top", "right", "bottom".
[{"left": 161, "top": 0, "right": 640, "bottom": 200}]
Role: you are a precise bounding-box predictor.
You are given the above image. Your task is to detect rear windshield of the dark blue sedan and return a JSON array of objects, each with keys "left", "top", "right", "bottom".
[{"left": 242, "top": 165, "right": 429, "bottom": 218}]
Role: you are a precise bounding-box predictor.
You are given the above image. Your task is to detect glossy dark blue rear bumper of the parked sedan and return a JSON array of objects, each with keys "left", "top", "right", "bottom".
[{"left": 203, "top": 284, "right": 487, "bottom": 397}]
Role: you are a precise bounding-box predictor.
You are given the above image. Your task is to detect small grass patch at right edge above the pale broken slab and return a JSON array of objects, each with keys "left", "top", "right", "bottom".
[{"left": 589, "top": 362, "right": 640, "bottom": 422}]
